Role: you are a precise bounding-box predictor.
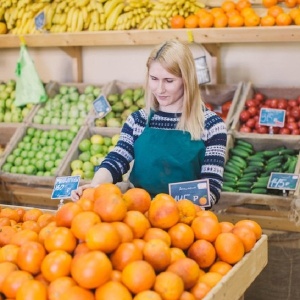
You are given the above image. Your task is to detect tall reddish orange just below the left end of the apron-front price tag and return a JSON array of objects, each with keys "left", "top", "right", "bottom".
[{"left": 148, "top": 193, "right": 180, "bottom": 229}]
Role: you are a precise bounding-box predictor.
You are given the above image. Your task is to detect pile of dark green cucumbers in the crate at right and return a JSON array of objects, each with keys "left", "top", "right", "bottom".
[{"left": 222, "top": 139, "right": 299, "bottom": 195}]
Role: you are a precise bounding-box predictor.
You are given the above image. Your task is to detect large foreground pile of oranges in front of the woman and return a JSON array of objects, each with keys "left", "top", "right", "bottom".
[{"left": 0, "top": 184, "right": 262, "bottom": 300}]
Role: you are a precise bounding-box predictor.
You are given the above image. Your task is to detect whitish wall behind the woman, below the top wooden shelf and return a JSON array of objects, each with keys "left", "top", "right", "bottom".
[{"left": 0, "top": 42, "right": 300, "bottom": 87}]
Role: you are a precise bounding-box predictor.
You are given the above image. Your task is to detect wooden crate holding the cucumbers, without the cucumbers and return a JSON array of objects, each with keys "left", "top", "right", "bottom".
[{"left": 212, "top": 132, "right": 300, "bottom": 232}]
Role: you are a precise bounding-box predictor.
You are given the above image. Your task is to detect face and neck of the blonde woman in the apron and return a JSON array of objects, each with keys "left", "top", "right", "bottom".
[{"left": 149, "top": 62, "right": 183, "bottom": 113}]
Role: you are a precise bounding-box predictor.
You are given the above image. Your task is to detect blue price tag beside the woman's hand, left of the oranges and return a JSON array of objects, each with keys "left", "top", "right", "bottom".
[{"left": 51, "top": 175, "right": 80, "bottom": 199}]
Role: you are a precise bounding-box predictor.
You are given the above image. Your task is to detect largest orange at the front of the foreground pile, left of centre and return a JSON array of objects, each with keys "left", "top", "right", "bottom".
[{"left": 71, "top": 251, "right": 112, "bottom": 289}]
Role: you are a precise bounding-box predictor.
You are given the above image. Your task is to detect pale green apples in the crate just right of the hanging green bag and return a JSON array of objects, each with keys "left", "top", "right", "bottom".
[{"left": 33, "top": 85, "right": 101, "bottom": 126}]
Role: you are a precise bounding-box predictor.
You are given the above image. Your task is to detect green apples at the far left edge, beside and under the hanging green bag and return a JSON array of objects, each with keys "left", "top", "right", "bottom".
[{"left": 0, "top": 79, "right": 33, "bottom": 123}]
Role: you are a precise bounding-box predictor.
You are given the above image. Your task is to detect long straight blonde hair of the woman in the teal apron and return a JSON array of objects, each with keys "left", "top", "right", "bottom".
[{"left": 145, "top": 39, "right": 205, "bottom": 140}]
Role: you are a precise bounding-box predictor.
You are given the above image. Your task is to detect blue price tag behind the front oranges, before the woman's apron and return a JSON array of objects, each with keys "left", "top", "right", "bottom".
[{"left": 169, "top": 179, "right": 211, "bottom": 207}]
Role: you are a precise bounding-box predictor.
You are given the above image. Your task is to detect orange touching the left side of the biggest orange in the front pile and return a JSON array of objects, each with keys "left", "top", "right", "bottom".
[{"left": 41, "top": 250, "right": 72, "bottom": 282}]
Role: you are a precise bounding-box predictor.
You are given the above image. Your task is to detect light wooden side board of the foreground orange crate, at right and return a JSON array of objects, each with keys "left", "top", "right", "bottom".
[{"left": 203, "top": 235, "right": 268, "bottom": 300}]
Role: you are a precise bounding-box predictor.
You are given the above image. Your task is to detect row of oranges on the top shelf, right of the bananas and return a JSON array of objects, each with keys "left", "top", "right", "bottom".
[{"left": 170, "top": 0, "right": 300, "bottom": 28}]
